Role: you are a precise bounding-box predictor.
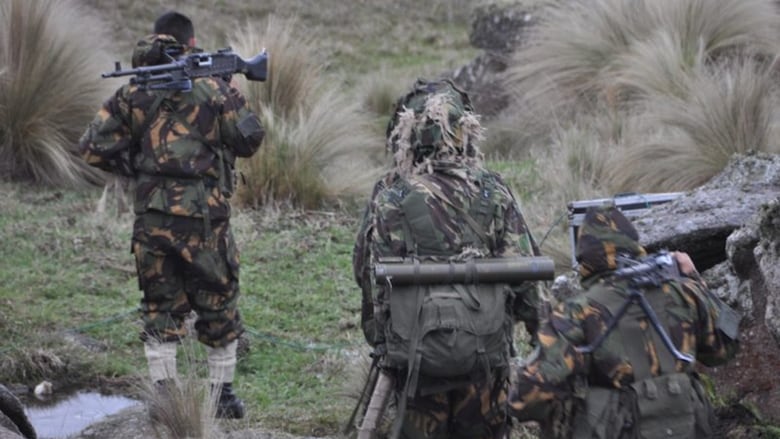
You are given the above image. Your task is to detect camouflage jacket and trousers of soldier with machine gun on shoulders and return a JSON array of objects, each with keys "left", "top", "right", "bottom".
[{"left": 80, "top": 35, "right": 263, "bottom": 347}]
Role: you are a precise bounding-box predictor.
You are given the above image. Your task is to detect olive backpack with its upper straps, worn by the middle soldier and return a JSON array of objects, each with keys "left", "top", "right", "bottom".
[{"left": 380, "top": 171, "right": 513, "bottom": 384}]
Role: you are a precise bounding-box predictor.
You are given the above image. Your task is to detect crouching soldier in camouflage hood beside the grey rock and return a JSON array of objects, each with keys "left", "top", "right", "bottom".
[{"left": 509, "top": 206, "right": 739, "bottom": 439}]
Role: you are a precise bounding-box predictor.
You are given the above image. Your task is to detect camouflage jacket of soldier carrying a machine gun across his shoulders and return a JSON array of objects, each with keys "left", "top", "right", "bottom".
[{"left": 80, "top": 72, "right": 263, "bottom": 219}]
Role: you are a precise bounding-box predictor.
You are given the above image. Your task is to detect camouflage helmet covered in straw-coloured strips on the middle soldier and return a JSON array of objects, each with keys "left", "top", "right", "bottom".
[{"left": 386, "top": 79, "right": 483, "bottom": 171}]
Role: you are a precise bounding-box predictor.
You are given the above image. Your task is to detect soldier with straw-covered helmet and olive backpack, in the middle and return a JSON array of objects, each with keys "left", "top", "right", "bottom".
[{"left": 353, "top": 80, "right": 539, "bottom": 439}]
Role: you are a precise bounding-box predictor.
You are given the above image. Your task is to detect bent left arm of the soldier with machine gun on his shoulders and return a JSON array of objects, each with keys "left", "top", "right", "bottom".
[{"left": 79, "top": 87, "right": 134, "bottom": 176}]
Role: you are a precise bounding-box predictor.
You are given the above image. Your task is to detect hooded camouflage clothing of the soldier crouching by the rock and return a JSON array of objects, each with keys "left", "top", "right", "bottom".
[{"left": 509, "top": 207, "right": 738, "bottom": 438}]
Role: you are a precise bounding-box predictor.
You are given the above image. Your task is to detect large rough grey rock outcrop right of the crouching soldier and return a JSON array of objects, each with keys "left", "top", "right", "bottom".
[{"left": 634, "top": 154, "right": 780, "bottom": 423}]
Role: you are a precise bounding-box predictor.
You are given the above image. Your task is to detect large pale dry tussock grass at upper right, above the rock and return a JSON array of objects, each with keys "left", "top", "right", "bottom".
[{"left": 500, "top": 0, "right": 780, "bottom": 262}]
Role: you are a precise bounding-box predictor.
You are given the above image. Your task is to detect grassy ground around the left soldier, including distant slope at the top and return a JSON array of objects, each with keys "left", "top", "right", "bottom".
[{"left": 0, "top": 0, "right": 512, "bottom": 435}]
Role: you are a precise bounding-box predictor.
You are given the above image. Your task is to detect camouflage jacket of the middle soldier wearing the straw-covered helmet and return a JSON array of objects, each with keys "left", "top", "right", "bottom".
[{"left": 352, "top": 161, "right": 540, "bottom": 345}]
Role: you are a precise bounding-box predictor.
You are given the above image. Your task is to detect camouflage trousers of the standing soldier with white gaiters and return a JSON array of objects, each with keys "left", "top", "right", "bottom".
[{"left": 132, "top": 213, "right": 244, "bottom": 347}]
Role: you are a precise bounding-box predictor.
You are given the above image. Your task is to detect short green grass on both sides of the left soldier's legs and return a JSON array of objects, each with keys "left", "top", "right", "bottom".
[{"left": 0, "top": 180, "right": 372, "bottom": 434}]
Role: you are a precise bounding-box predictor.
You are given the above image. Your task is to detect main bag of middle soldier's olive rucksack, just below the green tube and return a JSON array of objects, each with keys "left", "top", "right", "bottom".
[{"left": 384, "top": 284, "right": 511, "bottom": 378}]
